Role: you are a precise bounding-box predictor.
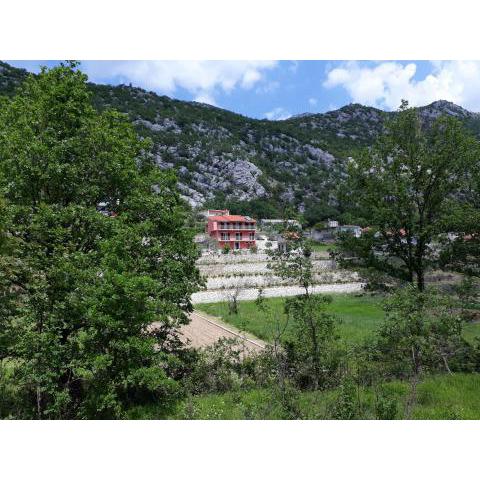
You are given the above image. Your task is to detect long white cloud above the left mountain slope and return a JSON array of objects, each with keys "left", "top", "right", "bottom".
[{"left": 82, "top": 60, "right": 277, "bottom": 103}]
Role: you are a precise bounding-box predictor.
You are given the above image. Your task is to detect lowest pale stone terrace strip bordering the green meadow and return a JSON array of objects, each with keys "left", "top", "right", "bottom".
[{"left": 192, "top": 282, "right": 363, "bottom": 304}]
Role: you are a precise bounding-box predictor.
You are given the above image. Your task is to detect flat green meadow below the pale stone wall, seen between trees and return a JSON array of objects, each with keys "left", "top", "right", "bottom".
[{"left": 198, "top": 295, "right": 384, "bottom": 343}]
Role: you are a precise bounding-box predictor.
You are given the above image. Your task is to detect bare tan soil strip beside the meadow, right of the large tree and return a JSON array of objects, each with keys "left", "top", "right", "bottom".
[{"left": 180, "top": 312, "right": 265, "bottom": 353}]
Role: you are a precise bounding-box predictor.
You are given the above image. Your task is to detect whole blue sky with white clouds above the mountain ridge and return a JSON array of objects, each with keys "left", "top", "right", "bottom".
[{"left": 8, "top": 60, "right": 480, "bottom": 120}]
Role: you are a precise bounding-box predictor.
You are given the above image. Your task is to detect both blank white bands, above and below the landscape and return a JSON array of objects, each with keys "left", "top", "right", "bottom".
[{"left": 0, "top": 0, "right": 480, "bottom": 480}]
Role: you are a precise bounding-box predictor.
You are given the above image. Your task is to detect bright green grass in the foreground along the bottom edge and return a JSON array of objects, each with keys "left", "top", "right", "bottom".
[{"left": 165, "top": 373, "right": 480, "bottom": 420}]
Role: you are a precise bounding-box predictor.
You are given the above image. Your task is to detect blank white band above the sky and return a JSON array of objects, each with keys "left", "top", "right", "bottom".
[{"left": 0, "top": 0, "right": 479, "bottom": 60}]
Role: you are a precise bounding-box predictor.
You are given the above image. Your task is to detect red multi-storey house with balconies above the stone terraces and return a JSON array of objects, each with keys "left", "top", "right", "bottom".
[{"left": 207, "top": 214, "right": 257, "bottom": 250}]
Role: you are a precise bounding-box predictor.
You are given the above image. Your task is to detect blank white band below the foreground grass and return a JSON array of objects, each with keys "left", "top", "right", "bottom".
[{"left": 0, "top": 421, "right": 478, "bottom": 480}]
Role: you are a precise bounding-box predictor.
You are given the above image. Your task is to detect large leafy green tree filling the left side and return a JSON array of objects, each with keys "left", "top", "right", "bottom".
[{"left": 0, "top": 62, "right": 199, "bottom": 418}]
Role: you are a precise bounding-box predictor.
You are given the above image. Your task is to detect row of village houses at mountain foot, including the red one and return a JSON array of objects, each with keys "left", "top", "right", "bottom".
[{"left": 195, "top": 209, "right": 362, "bottom": 253}]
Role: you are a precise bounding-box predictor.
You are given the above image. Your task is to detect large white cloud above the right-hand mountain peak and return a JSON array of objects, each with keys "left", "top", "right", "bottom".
[{"left": 323, "top": 61, "right": 480, "bottom": 111}]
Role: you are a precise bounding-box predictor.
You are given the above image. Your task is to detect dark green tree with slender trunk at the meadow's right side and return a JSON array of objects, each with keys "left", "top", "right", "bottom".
[{"left": 337, "top": 102, "right": 478, "bottom": 290}]
